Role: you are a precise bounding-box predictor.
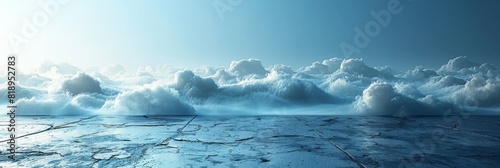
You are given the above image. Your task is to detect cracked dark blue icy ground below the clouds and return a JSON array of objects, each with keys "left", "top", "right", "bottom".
[{"left": 0, "top": 116, "right": 500, "bottom": 167}]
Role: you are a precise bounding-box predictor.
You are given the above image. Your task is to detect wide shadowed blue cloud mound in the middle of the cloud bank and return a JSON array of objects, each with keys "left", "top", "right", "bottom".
[{"left": 203, "top": 71, "right": 340, "bottom": 108}]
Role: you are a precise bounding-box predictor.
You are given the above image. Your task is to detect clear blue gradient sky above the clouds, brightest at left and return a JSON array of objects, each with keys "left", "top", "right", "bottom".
[{"left": 0, "top": 0, "right": 500, "bottom": 70}]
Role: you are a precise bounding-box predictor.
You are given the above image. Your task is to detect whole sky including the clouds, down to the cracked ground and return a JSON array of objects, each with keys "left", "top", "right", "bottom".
[{"left": 0, "top": 0, "right": 500, "bottom": 116}]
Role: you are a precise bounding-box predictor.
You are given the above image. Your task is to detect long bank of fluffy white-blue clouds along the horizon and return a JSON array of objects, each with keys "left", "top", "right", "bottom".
[{"left": 4, "top": 57, "right": 500, "bottom": 116}]
